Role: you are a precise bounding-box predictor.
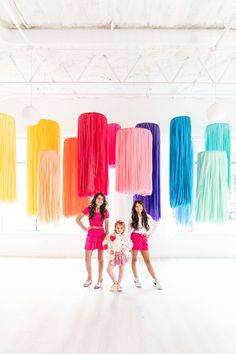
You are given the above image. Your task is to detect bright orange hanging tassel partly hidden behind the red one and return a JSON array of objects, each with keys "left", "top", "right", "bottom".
[{"left": 63, "top": 138, "right": 90, "bottom": 217}]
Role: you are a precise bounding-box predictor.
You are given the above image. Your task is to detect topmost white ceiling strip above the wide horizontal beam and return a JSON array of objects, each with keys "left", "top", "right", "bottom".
[{"left": 0, "top": 0, "right": 236, "bottom": 29}]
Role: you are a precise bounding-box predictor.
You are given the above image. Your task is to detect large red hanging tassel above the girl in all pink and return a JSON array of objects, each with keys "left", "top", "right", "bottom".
[{"left": 78, "top": 112, "right": 108, "bottom": 197}]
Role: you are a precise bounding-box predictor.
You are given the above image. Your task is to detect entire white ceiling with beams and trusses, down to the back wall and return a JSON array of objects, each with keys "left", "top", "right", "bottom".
[{"left": 0, "top": 0, "right": 236, "bottom": 100}]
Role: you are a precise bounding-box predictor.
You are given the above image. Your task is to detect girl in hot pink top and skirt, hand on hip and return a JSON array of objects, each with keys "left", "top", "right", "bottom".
[{"left": 76, "top": 193, "right": 109, "bottom": 289}]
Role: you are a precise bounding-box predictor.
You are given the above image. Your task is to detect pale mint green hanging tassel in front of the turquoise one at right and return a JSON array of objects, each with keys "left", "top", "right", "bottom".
[{"left": 196, "top": 151, "right": 229, "bottom": 223}]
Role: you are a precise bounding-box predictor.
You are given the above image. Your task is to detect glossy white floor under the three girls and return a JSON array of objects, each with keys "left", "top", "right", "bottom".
[{"left": 0, "top": 258, "right": 236, "bottom": 354}]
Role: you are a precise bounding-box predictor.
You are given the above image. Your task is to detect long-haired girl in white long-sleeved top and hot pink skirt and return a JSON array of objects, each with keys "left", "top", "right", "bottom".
[{"left": 128, "top": 200, "right": 162, "bottom": 290}]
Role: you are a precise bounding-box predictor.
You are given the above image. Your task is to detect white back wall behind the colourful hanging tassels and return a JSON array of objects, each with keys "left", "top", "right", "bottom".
[{"left": 0, "top": 97, "right": 236, "bottom": 257}]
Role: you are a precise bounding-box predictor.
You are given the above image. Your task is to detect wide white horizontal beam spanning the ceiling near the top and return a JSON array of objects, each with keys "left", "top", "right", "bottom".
[{"left": 0, "top": 28, "right": 236, "bottom": 51}]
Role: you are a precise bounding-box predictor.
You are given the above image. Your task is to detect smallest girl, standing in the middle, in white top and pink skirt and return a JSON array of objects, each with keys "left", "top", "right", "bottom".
[{"left": 103, "top": 220, "right": 132, "bottom": 292}]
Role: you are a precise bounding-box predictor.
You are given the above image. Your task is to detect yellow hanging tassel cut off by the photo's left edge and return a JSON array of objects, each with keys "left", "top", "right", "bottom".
[{"left": 0, "top": 113, "right": 16, "bottom": 203}]
